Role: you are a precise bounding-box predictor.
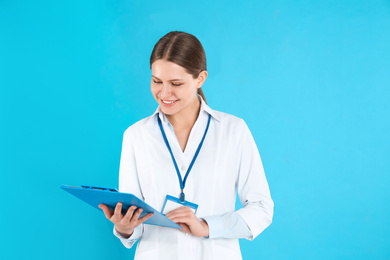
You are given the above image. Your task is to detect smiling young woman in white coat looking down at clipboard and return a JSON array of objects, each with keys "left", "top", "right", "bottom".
[{"left": 101, "top": 31, "right": 273, "bottom": 260}]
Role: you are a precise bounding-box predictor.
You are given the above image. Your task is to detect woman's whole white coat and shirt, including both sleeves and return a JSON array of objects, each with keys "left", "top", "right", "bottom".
[{"left": 114, "top": 96, "right": 273, "bottom": 260}]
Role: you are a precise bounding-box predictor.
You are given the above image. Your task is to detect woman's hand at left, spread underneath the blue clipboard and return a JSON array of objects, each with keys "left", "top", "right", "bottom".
[{"left": 99, "top": 202, "right": 153, "bottom": 238}]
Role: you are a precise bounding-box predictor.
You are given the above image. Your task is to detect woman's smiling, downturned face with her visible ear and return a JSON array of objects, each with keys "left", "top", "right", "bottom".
[{"left": 151, "top": 60, "right": 207, "bottom": 116}]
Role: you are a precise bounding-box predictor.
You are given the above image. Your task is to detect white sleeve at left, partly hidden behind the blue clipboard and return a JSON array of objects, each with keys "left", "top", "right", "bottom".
[{"left": 114, "top": 127, "right": 144, "bottom": 248}]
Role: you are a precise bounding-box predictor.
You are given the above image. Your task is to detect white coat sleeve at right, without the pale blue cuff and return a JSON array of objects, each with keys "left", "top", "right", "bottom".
[{"left": 236, "top": 120, "right": 274, "bottom": 240}]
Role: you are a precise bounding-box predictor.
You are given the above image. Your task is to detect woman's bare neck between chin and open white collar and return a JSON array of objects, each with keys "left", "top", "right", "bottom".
[{"left": 166, "top": 98, "right": 200, "bottom": 129}]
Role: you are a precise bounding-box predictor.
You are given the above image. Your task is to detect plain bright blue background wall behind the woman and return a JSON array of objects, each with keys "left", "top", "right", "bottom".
[{"left": 0, "top": 0, "right": 390, "bottom": 260}]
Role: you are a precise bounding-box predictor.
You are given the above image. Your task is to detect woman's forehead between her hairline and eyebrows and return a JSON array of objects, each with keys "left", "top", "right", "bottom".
[{"left": 152, "top": 60, "right": 191, "bottom": 80}]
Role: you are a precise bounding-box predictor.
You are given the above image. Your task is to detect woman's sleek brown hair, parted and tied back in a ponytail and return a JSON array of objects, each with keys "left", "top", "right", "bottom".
[{"left": 150, "top": 31, "right": 207, "bottom": 102}]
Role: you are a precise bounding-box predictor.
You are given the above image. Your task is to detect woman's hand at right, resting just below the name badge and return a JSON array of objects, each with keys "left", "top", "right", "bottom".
[{"left": 165, "top": 206, "right": 209, "bottom": 237}]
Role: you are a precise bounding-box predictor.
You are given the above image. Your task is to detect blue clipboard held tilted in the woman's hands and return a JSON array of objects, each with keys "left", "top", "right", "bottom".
[{"left": 60, "top": 185, "right": 181, "bottom": 229}]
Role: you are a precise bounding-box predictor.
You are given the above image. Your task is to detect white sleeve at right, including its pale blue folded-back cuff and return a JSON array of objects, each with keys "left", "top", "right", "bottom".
[{"left": 202, "top": 120, "right": 273, "bottom": 240}]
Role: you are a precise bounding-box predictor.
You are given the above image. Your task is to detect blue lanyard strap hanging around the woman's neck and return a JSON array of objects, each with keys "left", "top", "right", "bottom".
[{"left": 157, "top": 112, "right": 211, "bottom": 202}]
